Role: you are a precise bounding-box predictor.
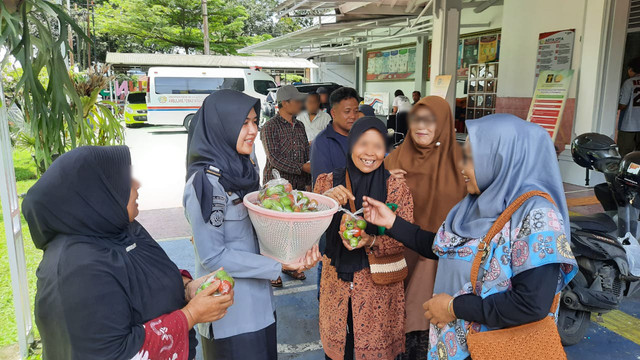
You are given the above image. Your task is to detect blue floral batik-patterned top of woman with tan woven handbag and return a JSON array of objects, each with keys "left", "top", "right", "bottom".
[{"left": 428, "top": 208, "right": 578, "bottom": 360}]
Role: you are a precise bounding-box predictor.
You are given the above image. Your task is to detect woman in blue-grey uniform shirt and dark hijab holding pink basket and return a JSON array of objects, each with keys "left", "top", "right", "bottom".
[{"left": 183, "top": 90, "right": 320, "bottom": 360}]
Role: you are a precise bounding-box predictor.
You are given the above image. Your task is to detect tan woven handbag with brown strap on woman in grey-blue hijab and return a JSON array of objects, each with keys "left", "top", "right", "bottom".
[{"left": 467, "top": 191, "right": 567, "bottom": 360}]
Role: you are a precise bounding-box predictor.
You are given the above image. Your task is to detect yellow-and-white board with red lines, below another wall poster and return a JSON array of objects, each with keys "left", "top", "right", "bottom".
[{"left": 527, "top": 70, "right": 573, "bottom": 141}]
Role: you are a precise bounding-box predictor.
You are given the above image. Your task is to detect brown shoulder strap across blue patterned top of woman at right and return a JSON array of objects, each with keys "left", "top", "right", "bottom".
[{"left": 470, "top": 191, "right": 555, "bottom": 294}]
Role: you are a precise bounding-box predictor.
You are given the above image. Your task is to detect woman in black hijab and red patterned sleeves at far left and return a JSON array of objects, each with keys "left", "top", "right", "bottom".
[{"left": 22, "top": 146, "right": 238, "bottom": 360}]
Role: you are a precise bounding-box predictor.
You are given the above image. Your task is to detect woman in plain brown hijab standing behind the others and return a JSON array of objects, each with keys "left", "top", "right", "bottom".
[{"left": 385, "top": 96, "right": 466, "bottom": 359}]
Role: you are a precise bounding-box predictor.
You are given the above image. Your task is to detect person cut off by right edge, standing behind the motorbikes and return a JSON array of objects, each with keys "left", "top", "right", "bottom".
[{"left": 618, "top": 57, "right": 640, "bottom": 156}]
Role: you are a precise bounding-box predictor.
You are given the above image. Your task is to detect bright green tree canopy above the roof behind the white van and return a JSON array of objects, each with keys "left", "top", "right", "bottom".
[{"left": 90, "top": 0, "right": 306, "bottom": 59}]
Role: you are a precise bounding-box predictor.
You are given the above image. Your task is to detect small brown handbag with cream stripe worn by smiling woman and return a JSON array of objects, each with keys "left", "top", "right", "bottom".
[{"left": 345, "top": 171, "right": 409, "bottom": 285}]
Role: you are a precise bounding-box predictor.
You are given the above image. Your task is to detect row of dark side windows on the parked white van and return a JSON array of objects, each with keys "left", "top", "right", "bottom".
[{"left": 155, "top": 77, "right": 244, "bottom": 94}]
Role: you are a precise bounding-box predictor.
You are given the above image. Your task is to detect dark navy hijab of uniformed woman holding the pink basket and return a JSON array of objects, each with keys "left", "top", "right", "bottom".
[{"left": 187, "top": 89, "right": 260, "bottom": 221}]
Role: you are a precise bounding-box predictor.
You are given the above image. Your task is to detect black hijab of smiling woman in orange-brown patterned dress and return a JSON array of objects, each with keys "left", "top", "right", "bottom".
[{"left": 326, "top": 116, "right": 389, "bottom": 281}]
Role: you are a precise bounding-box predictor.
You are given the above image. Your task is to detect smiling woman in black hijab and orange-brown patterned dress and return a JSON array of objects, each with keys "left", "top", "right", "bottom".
[{"left": 315, "top": 116, "right": 413, "bottom": 360}]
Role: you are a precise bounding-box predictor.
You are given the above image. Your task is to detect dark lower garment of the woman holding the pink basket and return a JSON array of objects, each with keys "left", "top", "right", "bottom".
[{"left": 200, "top": 314, "right": 278, "bottom": 360}]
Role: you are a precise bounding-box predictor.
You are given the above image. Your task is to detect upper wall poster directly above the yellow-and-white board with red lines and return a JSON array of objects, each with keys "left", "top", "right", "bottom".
[{"left": 536, "top": 29, "right": 576, "bottom": 78}]
